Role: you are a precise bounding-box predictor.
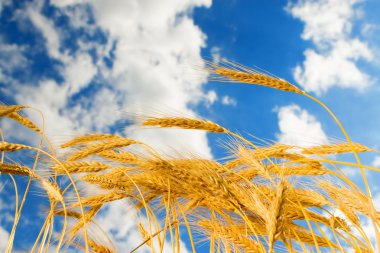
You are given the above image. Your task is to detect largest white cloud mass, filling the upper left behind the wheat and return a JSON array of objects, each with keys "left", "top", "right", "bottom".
[{"left": 6, "top": 0, "right": 217, "bottom": 158}]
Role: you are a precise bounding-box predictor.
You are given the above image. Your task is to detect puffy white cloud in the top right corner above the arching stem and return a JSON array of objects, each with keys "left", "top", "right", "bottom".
[{"left": 286, "top": 0, "right": 373, "bottom": 95}]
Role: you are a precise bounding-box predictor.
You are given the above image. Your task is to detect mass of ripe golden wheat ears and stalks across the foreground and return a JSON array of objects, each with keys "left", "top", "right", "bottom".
[{"left": 0, "top": 60, "right": 380, "bottom": 253}]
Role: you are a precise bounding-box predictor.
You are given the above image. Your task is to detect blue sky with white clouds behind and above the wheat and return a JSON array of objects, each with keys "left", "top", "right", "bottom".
[{"left": 0, "top": 0, "right": 380, "bottom": 251}]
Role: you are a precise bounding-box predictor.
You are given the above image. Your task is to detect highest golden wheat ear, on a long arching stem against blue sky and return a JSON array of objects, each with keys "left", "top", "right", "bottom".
[{"left": 204, "top": 59, "right": 304, "bottom": 94}]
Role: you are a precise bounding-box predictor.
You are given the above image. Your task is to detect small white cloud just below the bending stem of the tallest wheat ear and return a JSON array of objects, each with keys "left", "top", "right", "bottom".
[{"left": 277, "top": 105, "right": 328, "bottom": 147}]
